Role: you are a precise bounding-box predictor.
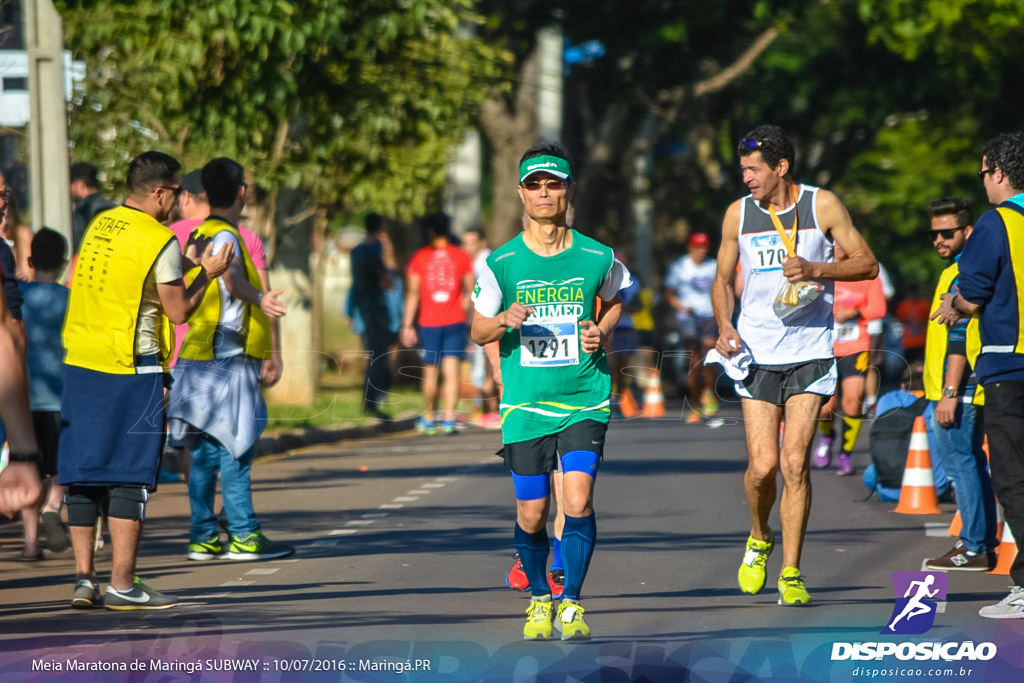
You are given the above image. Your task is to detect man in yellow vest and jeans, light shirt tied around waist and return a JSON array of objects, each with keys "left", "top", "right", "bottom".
[{"left": 168, "top": 158, "right": 295, "bottom": 560}]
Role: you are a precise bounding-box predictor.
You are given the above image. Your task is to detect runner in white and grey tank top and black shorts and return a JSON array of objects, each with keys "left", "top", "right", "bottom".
[{"left": 712, "top": 125, "right": 878, "bottom": 605}]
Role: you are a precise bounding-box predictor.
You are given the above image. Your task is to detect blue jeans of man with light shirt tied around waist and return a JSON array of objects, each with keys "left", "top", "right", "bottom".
[{"left": 188, "top": 434, "right": 259, "bottom": 543}]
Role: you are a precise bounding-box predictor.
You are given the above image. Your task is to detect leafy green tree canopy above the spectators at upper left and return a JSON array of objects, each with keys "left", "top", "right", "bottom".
[{"left": 63, "top": 0, "right": 506, "bottom": 222}]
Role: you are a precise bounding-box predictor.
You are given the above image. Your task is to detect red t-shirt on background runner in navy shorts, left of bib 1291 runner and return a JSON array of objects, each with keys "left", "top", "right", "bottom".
[{"left": 406, "top": 245, "right": 473, "bottom": 328}]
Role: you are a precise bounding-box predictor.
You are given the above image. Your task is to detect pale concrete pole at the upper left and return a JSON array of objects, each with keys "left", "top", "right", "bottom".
[{"left": 25, "top": 0, "right": 72, "bottom": 245}]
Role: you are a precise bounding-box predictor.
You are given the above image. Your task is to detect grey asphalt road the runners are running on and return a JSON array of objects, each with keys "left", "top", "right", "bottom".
[{"left": 0, "top": 403, "right": 1024, "bottom": 681}]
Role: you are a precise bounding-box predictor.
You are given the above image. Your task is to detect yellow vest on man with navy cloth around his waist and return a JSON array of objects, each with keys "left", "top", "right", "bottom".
[{"left": 61, "top": 206, "right": 174, "bottom": 375}]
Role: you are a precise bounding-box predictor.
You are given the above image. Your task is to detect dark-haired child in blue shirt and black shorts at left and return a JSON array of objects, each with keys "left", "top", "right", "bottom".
[{"left": 22, "top": 227, "right": 70, "bottom": 561}]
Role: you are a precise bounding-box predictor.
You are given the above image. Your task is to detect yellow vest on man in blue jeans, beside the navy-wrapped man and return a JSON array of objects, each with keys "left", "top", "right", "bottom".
[{"left": 178, "top": 216, "right": 270, "bottom": 360}]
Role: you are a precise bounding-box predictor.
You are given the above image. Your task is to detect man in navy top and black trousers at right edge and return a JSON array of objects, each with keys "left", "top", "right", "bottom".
[{"left": 932, "top": 131, "right": 1024, "bottom": 618}]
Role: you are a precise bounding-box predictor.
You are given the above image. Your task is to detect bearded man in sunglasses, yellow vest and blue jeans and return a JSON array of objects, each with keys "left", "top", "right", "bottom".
[{"left": 924, "top": 197, "right": 999, "bottom": 571}]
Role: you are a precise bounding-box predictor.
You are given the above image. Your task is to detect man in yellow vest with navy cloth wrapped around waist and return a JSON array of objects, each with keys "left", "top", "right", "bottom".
[{"left": 57, "top": 152, "right": 233, "bottom": 609}]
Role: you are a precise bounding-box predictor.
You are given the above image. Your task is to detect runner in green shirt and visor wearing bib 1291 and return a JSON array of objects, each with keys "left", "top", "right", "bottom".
[{"left": 472, "top": 142, "right": 630, "bottom": 640}]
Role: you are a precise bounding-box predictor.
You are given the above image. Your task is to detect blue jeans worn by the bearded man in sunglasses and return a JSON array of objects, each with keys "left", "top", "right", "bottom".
[{"left": 925, "top": 401, "right": 999, "bottom": 553}]
